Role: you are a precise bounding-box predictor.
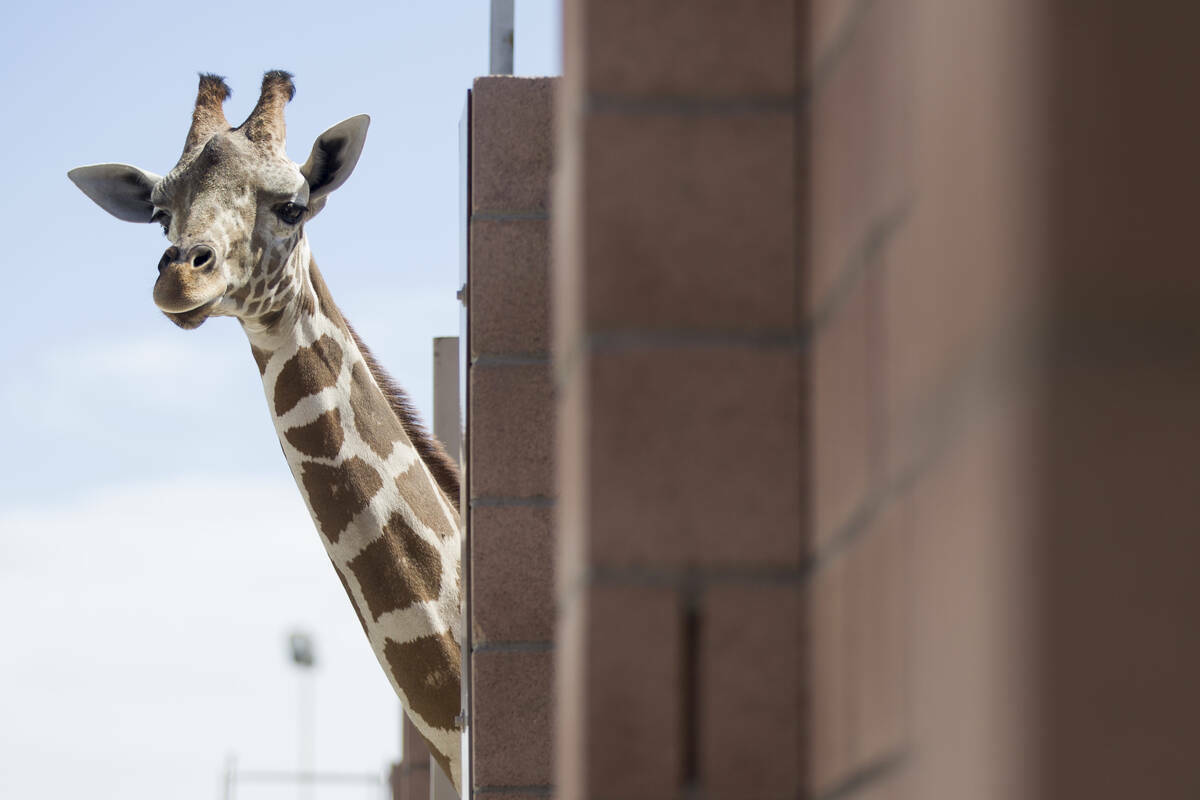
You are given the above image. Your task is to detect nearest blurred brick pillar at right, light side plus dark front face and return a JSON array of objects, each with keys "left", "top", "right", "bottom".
[{"left": 806, "top": 0, "right": 1200, "bottom": 800}]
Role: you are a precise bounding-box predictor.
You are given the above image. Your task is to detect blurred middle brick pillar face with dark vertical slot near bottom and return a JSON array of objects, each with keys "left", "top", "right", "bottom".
[{"left": 554, "top": 0, "right": 806, "bottom": 799}]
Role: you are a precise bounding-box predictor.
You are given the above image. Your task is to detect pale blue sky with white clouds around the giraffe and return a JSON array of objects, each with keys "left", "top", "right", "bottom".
[{"left": 0, "top": 0, "right": 560, "bottom": 800}]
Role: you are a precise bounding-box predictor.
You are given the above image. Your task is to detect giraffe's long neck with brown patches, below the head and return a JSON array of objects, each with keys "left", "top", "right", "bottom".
[{"left": 245, "top": 239, "right": 462, "bottom": 787}]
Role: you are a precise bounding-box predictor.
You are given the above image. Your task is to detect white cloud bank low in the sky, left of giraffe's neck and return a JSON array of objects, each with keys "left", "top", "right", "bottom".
[{"left": 0, "top": 477, "right": 398, "bottom": 800}]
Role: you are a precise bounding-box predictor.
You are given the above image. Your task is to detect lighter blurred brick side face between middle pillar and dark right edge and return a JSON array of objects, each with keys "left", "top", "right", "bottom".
[{"left": 802, "top": 0, "right": 1038, "bottom": 799}]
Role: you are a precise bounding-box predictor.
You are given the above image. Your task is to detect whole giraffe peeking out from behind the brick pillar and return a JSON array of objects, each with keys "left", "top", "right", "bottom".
[{"left": 68, "top": 71, "right": 462, "bottom": 790}]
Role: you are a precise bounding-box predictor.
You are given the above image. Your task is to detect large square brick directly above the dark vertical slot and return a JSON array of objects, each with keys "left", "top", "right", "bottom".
[{"left": 587, "top": 348, "right": 802, "bottom": 566}]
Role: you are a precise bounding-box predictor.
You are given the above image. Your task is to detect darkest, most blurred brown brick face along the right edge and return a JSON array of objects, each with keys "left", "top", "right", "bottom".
[{"left": 1033, "top": 0, "right": 1200, "bottom": 800}]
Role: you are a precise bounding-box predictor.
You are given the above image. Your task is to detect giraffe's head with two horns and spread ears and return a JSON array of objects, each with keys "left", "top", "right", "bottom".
[{"left": 68, "top": 71, "right": 370, "bottom": 327}]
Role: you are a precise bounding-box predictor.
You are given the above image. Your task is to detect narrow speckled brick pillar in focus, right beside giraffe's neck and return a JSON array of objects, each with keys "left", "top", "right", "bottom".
[{"left": 463, "top": 77, "right": 557, "bottom": 800}]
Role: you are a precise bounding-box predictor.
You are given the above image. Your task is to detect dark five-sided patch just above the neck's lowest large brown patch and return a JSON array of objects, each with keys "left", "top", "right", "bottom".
[{"left": 349, "top": 512, "right": 442, "bottom": 621}]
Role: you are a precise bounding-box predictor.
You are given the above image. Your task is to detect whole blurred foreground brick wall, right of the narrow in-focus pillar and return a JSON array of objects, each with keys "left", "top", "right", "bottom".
[{"left": 553, "top": 0, "right": 1200, "bottom": 799}]
